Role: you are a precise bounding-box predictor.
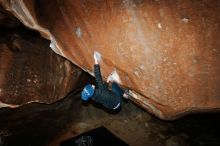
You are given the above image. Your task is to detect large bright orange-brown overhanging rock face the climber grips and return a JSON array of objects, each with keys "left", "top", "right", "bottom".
[{"left": 0, "top": 0, "right": 220, "bottom": 119}]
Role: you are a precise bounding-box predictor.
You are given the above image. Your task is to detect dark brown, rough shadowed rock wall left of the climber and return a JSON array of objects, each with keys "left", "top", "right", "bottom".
[{"left": 0, "top": 27, "right": 86, "bottom": 107}]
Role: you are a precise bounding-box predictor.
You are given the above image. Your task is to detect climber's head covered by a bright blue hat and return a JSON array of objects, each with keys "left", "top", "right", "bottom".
[{"left": 81, "top": 84, "right": 95, "bottom": 101}]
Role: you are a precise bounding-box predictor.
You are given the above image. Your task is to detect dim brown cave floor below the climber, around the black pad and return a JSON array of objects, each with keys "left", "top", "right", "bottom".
[{"left": 0, "top": 91, "right": 220, "bottom": 146}]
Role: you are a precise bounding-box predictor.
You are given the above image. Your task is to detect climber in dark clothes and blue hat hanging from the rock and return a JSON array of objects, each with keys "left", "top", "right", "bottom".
[{"left": 81, "top": 52, "right": 128, "bottom": 110}]
